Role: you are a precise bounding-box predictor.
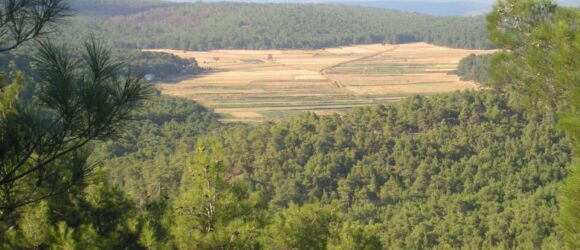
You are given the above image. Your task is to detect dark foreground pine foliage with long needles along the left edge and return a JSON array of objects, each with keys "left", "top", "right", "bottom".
[{"left": 0, "top": 0, "right": 150, "bottom": 249}]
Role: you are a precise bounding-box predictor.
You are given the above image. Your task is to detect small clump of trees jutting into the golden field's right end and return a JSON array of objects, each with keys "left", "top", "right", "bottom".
[{"left": 456, "top": 54, "right": 492, "bottom": 85}]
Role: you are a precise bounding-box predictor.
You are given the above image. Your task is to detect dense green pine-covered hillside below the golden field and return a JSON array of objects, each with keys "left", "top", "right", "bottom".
[{"left": 6, "top": 92, "right": 572, "bottom": 249}]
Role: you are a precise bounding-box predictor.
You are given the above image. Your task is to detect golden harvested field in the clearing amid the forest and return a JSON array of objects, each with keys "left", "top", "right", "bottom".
[{"left": 151, "top": 43, "right": 493, "bottom": 122}]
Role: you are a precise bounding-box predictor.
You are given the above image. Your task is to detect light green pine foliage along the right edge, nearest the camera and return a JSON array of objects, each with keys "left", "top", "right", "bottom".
[{"left": 487, "top": 0, "right": 580, "bottom": 248}]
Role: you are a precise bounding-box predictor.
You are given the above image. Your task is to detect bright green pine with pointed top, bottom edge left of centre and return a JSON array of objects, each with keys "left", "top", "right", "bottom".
[{"left": 172, "top": 142, "right": 265, "bottom": 249}]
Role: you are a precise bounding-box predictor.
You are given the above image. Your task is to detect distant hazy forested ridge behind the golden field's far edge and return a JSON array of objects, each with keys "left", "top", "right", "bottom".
[{"left": 59, "top": 2, "right": 492, "bottom": 50}]
